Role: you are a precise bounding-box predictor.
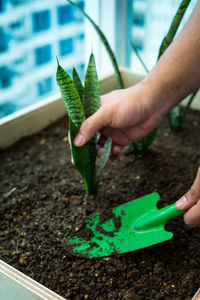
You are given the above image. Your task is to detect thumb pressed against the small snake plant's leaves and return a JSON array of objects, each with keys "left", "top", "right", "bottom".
[{"left": 74, "top": 108, "right": 105, "bottom": 147}]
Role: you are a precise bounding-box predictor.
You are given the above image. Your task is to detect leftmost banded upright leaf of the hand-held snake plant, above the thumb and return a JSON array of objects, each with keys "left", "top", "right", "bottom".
[{"left": 56, "top": 64, "right": 85, "bottom": 129}]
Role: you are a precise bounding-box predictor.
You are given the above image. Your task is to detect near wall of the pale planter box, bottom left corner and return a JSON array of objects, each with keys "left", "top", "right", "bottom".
[{"left": 0, "top": 260, "right": 65, "bottom": 300}]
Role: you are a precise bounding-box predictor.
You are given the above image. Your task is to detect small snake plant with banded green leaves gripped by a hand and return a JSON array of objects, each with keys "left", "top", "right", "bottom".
[{"left": 56, "top": 54, "right": 112, "bottom": 195}]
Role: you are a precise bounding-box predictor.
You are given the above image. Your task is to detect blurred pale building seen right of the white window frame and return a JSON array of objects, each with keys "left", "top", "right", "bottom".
[{"left": 131, "top": 0, "right": 197, "bottom": 74}]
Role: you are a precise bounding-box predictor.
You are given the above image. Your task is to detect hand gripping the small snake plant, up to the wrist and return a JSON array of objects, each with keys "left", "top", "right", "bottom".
[{"left": 74, "top": 81, "right": 162, "bottom": 158}]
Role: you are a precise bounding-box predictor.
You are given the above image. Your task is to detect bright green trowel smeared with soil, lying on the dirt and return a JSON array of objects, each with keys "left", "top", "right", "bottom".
[{"left": 65, "top": 193, "right": 185, "bottom": 258}]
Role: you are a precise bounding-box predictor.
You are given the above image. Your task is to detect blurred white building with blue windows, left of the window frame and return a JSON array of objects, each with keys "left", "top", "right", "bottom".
[{"left": 0, "top": 0, "right": 85, "bottom": 117}]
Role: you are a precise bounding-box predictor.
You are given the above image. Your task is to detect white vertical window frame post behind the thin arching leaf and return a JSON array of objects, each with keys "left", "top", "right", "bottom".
[{"left": 85, "top": 0, "right": 132, "bottom": 76}]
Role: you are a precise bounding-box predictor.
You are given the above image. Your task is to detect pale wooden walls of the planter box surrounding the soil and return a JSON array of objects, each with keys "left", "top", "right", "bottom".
[{"left": 0, "top": 69, "right": 200, "bottom": 300}]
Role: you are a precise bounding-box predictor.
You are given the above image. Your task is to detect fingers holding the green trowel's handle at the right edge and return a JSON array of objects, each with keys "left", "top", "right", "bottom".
[{"left": 176, "top": 167, "right": 200, "bottom": 227}]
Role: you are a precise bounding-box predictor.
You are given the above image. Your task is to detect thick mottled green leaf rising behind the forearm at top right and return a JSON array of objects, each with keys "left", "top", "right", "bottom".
[{"left": 158, "top": 0, "right": 191, "bottom": 59}]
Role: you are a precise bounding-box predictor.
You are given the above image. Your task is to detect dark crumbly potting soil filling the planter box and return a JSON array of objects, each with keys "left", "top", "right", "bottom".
[{"left": 0, "top": 111, "right": 200, "bottom": 300}]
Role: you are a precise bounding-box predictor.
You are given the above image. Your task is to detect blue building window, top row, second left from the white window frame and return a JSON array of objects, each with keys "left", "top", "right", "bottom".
[{"left": 32, "top": 10, "right": 50, "bottom": 32}]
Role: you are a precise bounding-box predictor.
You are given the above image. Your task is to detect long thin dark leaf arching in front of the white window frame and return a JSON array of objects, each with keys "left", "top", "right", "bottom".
[{"left": 66, "top": 0, "right": 124, "bottom": 89}]
